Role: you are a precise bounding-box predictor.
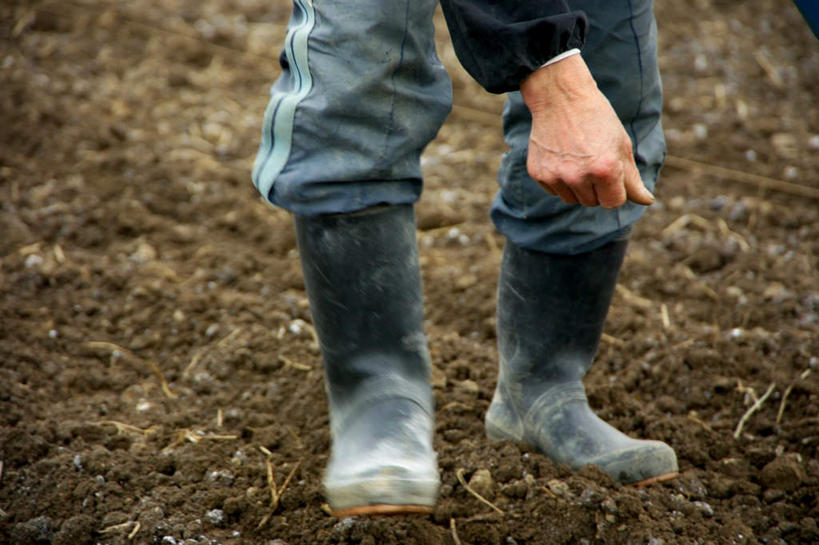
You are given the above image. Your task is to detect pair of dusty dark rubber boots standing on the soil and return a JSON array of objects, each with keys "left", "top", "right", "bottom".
[{"left": 295, "top": 205, "right": 677, "bottom": 515}]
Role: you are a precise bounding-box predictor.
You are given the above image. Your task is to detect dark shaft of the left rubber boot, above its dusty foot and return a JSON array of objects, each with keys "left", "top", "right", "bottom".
[{"left": 295, "top": 205, "right": 430, "bottom": 405}]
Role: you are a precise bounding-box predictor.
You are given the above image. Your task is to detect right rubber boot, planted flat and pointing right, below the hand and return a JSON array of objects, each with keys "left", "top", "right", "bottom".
[{"left": 486, "top": 240, "right": 677, "bottom": 484}]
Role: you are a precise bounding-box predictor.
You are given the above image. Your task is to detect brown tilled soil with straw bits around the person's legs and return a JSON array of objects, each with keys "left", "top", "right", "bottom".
[{"left": 0, "top": 0, "right": 819, "bottom": 545}]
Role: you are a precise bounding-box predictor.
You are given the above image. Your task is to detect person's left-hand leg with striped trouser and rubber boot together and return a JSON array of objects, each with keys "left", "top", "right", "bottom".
[{"left": 253, "top": 0, "right": 451, "bottom": 515}]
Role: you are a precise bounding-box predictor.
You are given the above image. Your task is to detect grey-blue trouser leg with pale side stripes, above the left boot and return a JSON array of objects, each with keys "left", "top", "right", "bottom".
[{"left": 253, "top": 0, "right": 452, "bottom": 216}]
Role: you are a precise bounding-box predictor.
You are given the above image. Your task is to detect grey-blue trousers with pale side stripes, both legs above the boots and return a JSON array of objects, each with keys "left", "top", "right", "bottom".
[{"left": 253, "top": 0, "right": 665, "bottom": 254}]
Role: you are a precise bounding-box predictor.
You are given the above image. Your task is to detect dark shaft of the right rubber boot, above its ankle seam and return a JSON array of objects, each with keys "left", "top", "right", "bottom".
[{"left": 498, "top": 240, "right": 628, "bottom": 383}]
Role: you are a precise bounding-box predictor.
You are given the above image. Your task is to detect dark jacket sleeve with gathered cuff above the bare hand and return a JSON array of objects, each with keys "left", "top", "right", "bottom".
[{"left": 441, "top": 0, "right": 587, "bottom": 93}]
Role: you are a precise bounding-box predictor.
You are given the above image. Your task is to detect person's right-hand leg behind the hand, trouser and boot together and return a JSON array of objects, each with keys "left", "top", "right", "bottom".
[{"left": 486, "top": 0, "right": 677, "bottom": 482}]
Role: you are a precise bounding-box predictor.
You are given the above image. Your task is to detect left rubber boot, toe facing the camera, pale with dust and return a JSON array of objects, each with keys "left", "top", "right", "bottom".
[{"left": 295, "top": 205, "right": 439, "bottom": 516}]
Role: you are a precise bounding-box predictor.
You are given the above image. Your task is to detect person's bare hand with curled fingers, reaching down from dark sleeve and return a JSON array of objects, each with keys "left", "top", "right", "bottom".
[{"left": 520, "top": 55, "right": 654, "bottom": 208}]
